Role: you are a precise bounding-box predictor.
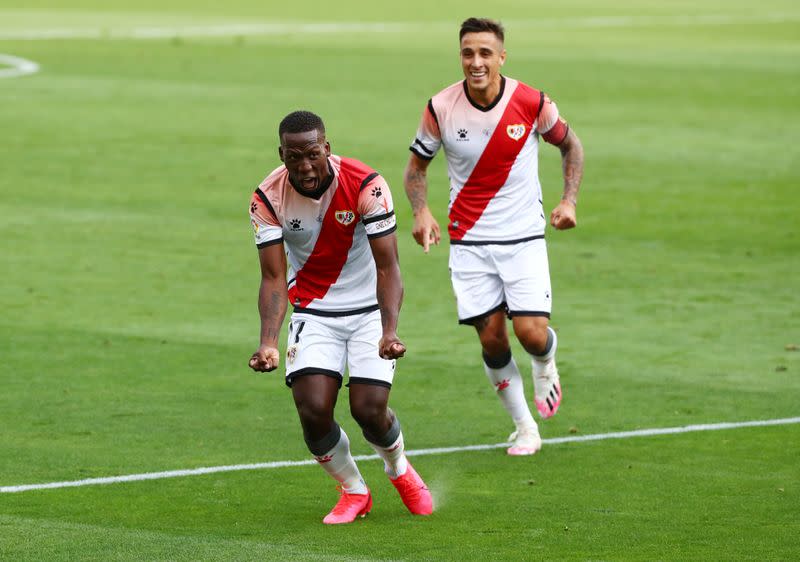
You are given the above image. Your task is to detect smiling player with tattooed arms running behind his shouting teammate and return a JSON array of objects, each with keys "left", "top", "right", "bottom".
[{"left": 404, "top": 18, "right": 583, "bottom": 455}]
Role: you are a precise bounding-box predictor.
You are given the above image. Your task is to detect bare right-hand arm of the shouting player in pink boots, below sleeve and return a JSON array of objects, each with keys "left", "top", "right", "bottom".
[{"left": 369, "top": 233, "right": 406, "bottom": 359}]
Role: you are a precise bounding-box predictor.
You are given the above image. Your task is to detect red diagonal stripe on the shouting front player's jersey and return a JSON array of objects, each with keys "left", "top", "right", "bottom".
[{"left": 289, "top": 179, "right": 361, "bottom": 307}]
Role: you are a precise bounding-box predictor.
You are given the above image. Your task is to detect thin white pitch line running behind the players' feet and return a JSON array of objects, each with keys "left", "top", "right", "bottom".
[{"left": 0, "top": 417, "right": 800, "bottom": 494}]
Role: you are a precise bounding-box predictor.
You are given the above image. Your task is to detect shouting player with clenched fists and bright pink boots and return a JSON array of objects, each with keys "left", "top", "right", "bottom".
[{"left": 249, "top": 111, "right": 433, "bottom": 524}]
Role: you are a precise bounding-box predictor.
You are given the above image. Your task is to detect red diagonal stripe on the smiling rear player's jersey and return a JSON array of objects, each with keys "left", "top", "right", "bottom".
[{"left": 448, "top": 83, "right": 542, "bottom": 240}]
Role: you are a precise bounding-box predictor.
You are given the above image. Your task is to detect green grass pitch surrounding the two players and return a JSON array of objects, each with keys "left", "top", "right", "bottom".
[{"left": 0, "top": 0, "right": 800, "bottom": 561}]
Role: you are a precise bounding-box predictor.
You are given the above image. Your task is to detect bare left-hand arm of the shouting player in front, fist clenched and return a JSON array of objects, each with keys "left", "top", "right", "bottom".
[{"left": 250, "top": 243, "right": 287, "bottom": 371}]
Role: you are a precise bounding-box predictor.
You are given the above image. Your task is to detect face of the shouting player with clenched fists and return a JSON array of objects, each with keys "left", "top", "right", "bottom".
[{"left": 278, "top": 131, "right": 331, "bottom": 193}]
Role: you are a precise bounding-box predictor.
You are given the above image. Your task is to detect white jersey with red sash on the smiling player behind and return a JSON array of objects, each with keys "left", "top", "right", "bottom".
[{"left": 410, "top": 77, "right": 567, "bottom": 244}]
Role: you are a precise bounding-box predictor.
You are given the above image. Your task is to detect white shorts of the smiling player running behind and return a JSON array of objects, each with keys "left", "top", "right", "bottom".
[{"left": 450, "top": 238, "right": 552, "bottom": 324}]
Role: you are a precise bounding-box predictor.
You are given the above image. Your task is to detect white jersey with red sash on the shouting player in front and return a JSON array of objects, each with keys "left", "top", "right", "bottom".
[{"left": 250, "top": 155, "right": 396, "bottom": 316}]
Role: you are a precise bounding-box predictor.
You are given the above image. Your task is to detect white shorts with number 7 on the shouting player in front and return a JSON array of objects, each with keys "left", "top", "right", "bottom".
[{"left": 286, "top": 310, "right": 395, "bottom": 388}]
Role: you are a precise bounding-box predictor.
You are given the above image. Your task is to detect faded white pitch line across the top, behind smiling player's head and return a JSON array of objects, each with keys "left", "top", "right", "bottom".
[{"left": 0, "top": 13, "right": 800, "bottom": 41}]
